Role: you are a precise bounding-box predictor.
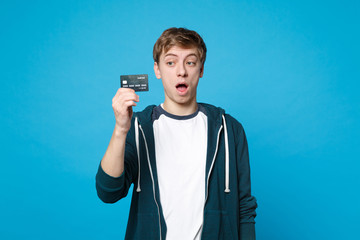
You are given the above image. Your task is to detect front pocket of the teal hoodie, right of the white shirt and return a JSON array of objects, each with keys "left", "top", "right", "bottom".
[{"left": 201, "top": 210, "right": 238, "bottom": 240}]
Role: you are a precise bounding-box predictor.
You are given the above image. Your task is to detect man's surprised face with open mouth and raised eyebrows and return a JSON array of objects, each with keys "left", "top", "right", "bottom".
[{"left": 154, "top": 46, "right": 204, "bottom": 106}]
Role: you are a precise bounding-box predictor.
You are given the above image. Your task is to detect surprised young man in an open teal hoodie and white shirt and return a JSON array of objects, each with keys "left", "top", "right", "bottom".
[{"left": 96, "top": 28, "right": 257, "bottom": 240}]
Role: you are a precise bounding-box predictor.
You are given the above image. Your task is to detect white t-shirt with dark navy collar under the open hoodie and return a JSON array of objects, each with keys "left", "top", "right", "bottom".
[{"left": 153, "top": 105, "right": 207, "bottom": 240}]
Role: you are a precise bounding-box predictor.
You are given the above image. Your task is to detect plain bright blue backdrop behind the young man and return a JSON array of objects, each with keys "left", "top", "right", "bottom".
[{"left": 0, "top": 0, "right": 360, "bottom": 240}]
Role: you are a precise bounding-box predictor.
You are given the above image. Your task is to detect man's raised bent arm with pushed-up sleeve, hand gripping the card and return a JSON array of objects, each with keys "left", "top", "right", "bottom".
[{"left": 96, "top": 88, "right": 139, "bottom": 202}]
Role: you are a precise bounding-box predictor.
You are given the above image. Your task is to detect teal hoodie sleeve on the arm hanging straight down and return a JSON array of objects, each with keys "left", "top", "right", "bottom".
[{"left": 236, "top": 123, "right": 257, "bottom": 240}]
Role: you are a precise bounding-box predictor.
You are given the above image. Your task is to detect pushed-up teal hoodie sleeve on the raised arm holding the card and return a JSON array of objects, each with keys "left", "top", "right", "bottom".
[{"left": 96, "top": 124, "right": 138, "bottom": 203}]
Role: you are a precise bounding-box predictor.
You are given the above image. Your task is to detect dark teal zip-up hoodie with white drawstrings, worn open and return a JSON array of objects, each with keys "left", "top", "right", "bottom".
[{"left": 96, "top": 103, "right": 257, "bottom": 240}]
